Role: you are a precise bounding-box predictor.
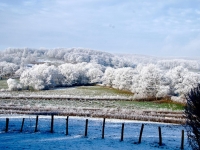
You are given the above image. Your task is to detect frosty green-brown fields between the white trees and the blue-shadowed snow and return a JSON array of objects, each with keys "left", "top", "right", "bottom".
[{"left": 0, "top": 81, "right": 185, "bottom": 123}]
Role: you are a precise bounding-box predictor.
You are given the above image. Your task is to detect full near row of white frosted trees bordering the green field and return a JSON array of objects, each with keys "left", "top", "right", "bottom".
[{"left": 8, "top": 63, "right": 200, "bottom": 101}]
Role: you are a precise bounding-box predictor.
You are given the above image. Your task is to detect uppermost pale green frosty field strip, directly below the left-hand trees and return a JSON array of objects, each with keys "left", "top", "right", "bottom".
[{"left": 0, "top": 85, "right": 134, "bottom": 99}]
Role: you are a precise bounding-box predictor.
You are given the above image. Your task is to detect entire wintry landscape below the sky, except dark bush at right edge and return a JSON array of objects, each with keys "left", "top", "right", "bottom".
[{"left": 0, "top": 48, "right": 197, "bottom": 150}]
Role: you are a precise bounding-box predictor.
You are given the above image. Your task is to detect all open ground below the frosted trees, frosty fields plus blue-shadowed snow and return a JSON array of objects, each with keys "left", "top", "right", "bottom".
[{"left": 0, "top": 83, "right": 190, "bottom": 150}]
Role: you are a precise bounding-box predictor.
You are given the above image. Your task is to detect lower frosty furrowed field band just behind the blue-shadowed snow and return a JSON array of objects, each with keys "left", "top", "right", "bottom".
[{"left": 0, "top": 99, "right": 185, "bottom": 124}]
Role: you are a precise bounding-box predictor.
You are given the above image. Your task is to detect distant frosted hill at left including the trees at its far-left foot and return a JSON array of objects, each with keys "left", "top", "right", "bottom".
[{"left": 0, "top": 48, "right": 135, "bottom": 78}]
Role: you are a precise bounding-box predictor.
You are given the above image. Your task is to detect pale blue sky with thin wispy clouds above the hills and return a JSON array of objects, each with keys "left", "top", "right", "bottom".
[{"left": 0, "top": 0, "right": 200, "bottom": 57}]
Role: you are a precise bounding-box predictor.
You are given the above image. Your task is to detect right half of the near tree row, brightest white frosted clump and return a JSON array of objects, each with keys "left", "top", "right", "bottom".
[{"left": 103, "top": 64, "right": 200, "bottom": 100}]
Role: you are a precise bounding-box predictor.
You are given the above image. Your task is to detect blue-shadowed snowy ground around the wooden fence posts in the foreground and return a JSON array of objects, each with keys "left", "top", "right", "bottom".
[{"left": 0, "top": 115, "right": 190, "bottom": 150}]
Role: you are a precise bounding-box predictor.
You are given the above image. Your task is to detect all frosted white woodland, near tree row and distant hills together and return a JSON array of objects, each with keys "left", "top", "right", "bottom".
[{"left": 0, "top": 48, "right": 200, "bottom": 100}]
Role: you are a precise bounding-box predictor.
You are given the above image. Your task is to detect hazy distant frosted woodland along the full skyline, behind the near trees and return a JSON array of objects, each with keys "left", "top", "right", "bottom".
[{"left": 0, "top": 48, "right": 200, "bottom": 71}]
